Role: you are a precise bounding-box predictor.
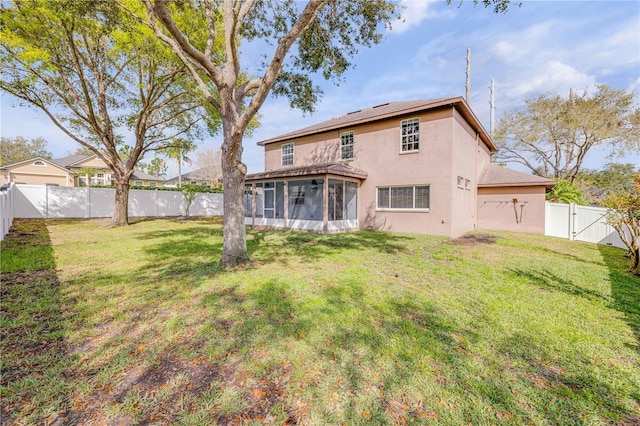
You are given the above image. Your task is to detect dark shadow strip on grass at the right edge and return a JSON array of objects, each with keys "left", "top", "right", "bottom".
[{"left": 598, "top": 245, "right": 640, "bottom": 354}]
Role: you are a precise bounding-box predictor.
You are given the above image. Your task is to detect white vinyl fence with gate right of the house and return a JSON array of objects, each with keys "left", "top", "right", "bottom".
[{"left": 544, "top": 202, "right": 627, "bottom": 248}]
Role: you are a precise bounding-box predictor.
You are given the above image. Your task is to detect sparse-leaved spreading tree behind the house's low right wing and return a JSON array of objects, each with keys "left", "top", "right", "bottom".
[{"left": 495, "top": 85, "right": 640, "bottom": 183}]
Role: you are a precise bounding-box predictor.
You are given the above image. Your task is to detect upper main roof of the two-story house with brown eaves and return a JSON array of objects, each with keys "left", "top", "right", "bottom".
[{"left": 258, "top": 97, "right": 497, "bottom": 151}]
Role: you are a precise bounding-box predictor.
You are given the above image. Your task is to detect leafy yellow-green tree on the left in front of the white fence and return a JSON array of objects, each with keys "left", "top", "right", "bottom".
[{"left": 0, "top": 0, "right": 218, "bottom": 226}]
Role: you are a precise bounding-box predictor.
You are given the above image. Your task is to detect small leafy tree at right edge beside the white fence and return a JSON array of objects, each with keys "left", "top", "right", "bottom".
[{"left": 604, "top": 175, "right": 640, "bottom": 275}]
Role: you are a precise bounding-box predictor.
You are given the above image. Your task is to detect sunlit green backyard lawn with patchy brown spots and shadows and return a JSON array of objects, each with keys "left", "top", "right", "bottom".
[{"left": 0, "top": 220, "right": 640, "bottom": 425}]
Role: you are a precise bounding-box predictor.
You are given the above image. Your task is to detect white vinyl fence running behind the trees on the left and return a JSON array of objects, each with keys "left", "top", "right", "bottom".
[{"left": 11, "top": 184, "right": 222, "bottom": 219}]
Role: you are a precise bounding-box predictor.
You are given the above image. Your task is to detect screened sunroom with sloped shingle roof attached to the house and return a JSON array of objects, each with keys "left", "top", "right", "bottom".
[{"left": 245, "top": 164, "right": 366, "bottom": 232}]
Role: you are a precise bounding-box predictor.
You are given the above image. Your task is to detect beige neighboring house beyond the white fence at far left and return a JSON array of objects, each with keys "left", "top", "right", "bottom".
[{"left": 0, "top": 155, "right": 162, "bottom": 187}]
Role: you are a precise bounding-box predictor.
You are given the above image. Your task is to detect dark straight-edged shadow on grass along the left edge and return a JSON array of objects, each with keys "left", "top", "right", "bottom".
[{"left": 0, "top": 219, "right": 73, "bottom": 424}]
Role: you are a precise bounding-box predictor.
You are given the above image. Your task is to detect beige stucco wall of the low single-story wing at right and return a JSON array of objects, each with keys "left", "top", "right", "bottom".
[{"left": 477, "top": 186, "right": 546, "bottom": 234}]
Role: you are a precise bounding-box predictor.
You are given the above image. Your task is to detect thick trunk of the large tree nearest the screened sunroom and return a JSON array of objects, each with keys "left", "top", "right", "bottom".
[{"left": 220, "top": 120, "right": 249, "bottom": 266}]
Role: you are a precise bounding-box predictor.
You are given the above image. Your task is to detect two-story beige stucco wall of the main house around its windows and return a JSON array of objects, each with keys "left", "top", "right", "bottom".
[{"left": 265, "top": 108, "right": 496, "bottom": 237}]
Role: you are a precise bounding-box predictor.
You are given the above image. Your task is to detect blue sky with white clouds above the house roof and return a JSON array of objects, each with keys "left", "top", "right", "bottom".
[{"left": 0, "top": 0, "right": 640, "bottom": 173}]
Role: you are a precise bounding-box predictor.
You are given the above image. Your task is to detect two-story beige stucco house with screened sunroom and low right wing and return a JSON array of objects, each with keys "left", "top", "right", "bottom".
[{"left": 245, "top": 97, "right": 554, "bottom": 237}]
